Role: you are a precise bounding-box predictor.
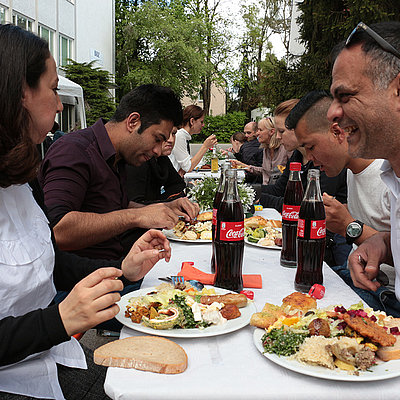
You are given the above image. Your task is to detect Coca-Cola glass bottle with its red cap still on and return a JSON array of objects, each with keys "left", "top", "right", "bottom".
[{"left": 281, "top": 162, "right": 303, "bottom": 268}]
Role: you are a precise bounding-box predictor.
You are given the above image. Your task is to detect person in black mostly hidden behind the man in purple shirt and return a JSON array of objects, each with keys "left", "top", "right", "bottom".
[{"left": 127, "top": 127, "right": 186, "bottom": 204}]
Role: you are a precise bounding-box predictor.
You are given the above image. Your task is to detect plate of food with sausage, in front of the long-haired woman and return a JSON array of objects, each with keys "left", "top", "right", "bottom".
[{"left": 116, "top": 282, "right": 256, "bottom": 338}]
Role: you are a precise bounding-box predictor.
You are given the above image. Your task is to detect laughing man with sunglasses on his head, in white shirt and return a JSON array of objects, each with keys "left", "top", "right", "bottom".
[{"left": 328, "top": 22, "right": 400, "bottom": 306}]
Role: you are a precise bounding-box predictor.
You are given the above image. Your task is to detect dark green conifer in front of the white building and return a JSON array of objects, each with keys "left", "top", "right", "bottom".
[{"left": 63, "top": 60, "right": 115, "bottom": 125}]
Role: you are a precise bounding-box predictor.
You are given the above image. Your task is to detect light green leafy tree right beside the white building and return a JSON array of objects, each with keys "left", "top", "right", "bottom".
[{"left": 116, "top": 0, "right": 206, "bottom": 101}]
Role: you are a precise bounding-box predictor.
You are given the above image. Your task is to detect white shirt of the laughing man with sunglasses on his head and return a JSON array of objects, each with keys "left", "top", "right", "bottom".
[{"left": 381, "top": 160, "right": 400, "bottom": 301}]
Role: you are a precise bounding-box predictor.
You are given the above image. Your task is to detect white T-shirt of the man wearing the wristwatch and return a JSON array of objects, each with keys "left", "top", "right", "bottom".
[{"left": 347, "top": 159, "right": 395, "bottom": 290}]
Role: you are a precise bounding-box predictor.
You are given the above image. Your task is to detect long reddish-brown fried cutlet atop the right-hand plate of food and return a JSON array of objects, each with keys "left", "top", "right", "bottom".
[{"left": 343, "top": 313, "right": 396, "bottom": 346}]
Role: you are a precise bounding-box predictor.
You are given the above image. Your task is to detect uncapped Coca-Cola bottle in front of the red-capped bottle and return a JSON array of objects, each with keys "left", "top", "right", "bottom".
[{"left": 294, "top": 169, "right": 326, "bottom": 293}]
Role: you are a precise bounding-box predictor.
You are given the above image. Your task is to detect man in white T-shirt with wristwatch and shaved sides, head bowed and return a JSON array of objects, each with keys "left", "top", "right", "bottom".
[{"left": 286, "top": 91, "right": 400, "bottom": 317}]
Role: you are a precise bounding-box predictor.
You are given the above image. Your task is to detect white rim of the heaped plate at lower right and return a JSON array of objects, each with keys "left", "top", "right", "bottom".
[{"left": 253, "top": 328, "right": 400, "bottom": 382}]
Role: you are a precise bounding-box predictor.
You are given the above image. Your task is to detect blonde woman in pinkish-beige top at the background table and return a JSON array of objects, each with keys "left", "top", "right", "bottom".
[{"left": 231, "top": 117, "right": 291, "bottom": 185}]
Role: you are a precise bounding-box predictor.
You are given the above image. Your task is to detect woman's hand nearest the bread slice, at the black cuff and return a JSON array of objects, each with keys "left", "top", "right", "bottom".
[{"left": 58, "top": 267, "right": 124, "bottom": 336}]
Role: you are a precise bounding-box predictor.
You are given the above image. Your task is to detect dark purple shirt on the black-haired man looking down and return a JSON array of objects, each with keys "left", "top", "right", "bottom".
[{"left": 39, "top": 120, "right": 143, "bottom": 260}]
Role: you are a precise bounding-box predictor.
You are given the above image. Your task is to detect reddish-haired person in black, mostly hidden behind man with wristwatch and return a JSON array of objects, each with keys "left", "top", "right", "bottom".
[{"left": 260, "top": 99, "right": 351, "bottom": 266}]
